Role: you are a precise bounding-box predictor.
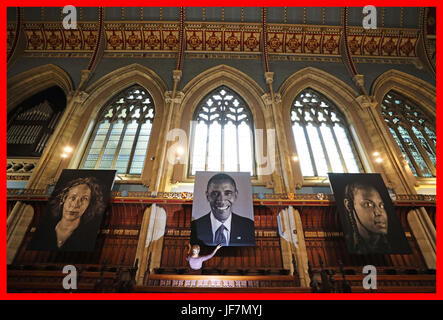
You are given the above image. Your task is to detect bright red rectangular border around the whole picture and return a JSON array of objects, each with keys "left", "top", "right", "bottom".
[{"left": 0, "top": 0, "right": 443, "bottom": 300}]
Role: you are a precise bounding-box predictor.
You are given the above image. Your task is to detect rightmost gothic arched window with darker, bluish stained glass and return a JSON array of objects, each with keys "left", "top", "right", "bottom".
[{"left": 381, "top": 91, "right": 437, "bottom": 177}]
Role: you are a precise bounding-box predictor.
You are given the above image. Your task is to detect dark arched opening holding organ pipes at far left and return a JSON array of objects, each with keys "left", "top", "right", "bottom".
[{"left": 7, "top": 87, "right": 66, "bottom": 157}]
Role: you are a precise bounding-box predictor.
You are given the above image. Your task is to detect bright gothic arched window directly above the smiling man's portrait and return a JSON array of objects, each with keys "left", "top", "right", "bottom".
[{"left": 189, "top": 86, "right": 255, "bottom": 175}]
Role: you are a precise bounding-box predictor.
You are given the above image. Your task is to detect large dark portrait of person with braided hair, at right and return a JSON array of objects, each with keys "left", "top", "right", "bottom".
[{"left": 328, "top": 173, "right": 410, "bottom": 254}]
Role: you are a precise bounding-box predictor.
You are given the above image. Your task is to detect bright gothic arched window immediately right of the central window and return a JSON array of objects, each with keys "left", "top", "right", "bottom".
[{"left": 291, "top": 88, "right": 363, "bottom": 177}]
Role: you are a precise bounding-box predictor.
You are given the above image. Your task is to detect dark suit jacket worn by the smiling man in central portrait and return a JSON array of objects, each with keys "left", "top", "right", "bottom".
[{"left": 191, "top": 212, "right": 255, "bottom": 246}]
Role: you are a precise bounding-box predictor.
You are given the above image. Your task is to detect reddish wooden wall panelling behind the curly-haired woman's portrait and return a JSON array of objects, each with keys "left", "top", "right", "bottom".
[{"left": 13, "top": 201, "right": 145, "bottom": 266}]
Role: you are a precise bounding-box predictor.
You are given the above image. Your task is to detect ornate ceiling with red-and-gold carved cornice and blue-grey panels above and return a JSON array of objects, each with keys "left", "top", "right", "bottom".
[{"left": 7, "top": 7, "right": 435, "bottom": 63}]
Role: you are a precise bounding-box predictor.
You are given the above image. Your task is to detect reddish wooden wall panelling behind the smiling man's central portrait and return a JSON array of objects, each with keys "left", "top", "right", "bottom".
[{"left": 161, "top": 205, "right": 283, "bottom": 271}]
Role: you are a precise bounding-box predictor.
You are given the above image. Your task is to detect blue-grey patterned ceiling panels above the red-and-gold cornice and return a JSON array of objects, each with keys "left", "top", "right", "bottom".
[{"left": 8, "top": 7, "right": 420, "bottom": 28}]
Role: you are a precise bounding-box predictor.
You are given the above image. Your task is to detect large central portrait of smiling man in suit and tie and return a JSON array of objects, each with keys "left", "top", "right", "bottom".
[{"left": 191, "top": 171, "right": 255, "bottom": 246}]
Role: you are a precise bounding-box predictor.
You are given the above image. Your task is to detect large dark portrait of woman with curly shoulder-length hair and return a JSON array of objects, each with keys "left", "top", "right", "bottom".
[{"left": 28, "top": 169, "right": 116, "bottom": 252}]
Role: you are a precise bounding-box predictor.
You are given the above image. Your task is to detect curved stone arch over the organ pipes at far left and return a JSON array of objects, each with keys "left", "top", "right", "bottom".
[{"left": 7, "top": 64, "right": 74, "bottom": 113}]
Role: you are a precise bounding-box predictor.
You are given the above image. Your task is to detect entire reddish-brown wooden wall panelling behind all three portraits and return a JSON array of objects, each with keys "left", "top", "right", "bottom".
[{"left": 8, "top": 201, "right": 436, "bottom": 272}]
